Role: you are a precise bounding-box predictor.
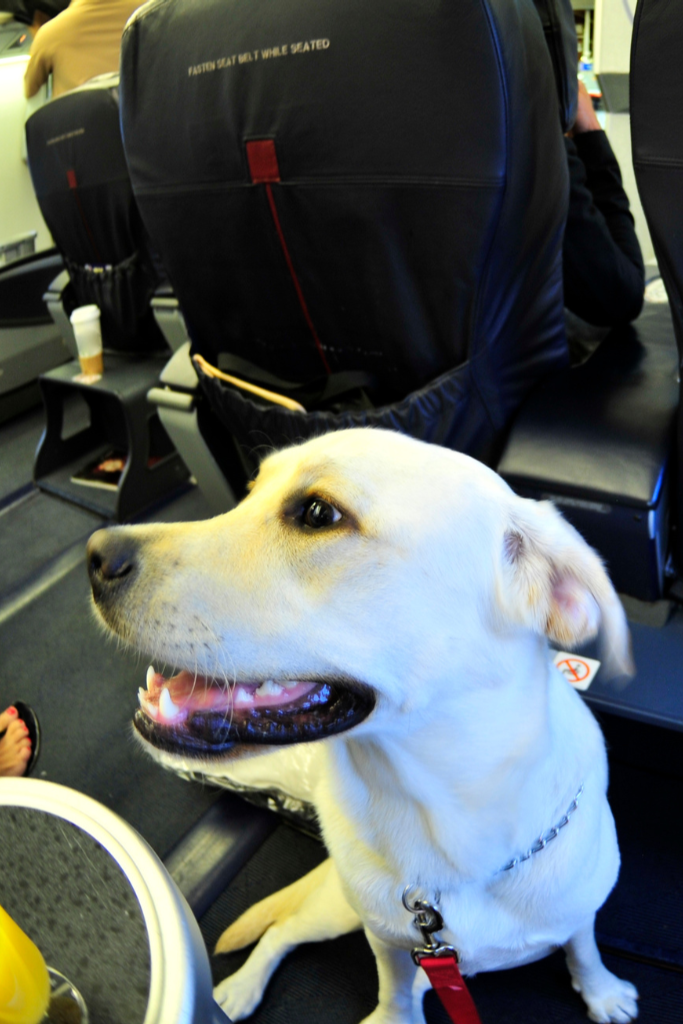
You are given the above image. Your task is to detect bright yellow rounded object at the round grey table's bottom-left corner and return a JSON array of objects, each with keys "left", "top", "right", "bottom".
[{"left": 0, "top": 906, "right": 50, "bottom": 1024}]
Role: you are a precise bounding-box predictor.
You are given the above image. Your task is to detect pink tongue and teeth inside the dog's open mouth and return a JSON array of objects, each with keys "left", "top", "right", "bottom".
[{"left": 138, "top": 666, "right": 317, "bottom": 725}]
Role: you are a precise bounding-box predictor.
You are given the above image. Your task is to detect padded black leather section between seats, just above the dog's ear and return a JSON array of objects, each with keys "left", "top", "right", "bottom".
[{"left": 497, "top": 304, "right": 678, "bottom": 602}]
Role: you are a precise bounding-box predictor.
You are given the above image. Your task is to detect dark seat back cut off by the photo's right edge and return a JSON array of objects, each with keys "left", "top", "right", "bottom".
[{"left": 630, "top": 0, "right": 683, "bottom": 573}]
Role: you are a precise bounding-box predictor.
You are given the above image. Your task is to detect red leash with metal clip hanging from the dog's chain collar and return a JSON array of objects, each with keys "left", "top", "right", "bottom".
[{"left": 403, "top": 886, "right": 481, "bottom": 1024}]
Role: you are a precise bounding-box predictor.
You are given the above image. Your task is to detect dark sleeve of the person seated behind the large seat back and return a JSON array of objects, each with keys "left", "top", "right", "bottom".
[{"left": 562, "top": 131, "right": 645, "bottom": 327}]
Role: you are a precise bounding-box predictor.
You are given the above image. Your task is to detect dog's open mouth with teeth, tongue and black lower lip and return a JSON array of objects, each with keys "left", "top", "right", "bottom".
[{"left": 133, "top": 667, "right": 375, "bottom": 756}]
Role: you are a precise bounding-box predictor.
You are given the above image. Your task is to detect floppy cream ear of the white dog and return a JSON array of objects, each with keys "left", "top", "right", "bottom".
[{"left": 502, "top": 498, "right": 635, "bottom": 676}]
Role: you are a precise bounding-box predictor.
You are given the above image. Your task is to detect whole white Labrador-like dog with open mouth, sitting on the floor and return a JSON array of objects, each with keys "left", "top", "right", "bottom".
[{"left": 89, "top": 430, "right": 637, "bottom": 1024}]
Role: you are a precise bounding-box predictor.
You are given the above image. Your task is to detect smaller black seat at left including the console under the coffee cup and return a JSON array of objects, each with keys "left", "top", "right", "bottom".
[{"left": 27, "top": 75, "right": 189, "bottom": 521}]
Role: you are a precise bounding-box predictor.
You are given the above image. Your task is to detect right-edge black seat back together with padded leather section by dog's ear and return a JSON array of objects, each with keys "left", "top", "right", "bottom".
[{"left": 497, "top": 0, "right": 683, "bottom": 602}]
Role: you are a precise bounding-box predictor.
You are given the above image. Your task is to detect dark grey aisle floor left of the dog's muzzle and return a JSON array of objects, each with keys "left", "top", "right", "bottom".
[{"left": 0, "top": 411, "right": 219, "bottom": 857}]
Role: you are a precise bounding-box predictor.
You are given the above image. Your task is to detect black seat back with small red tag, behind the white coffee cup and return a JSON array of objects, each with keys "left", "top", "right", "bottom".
[{"left": 27, "top": 76, "right": 167, "bottom": 352}]
